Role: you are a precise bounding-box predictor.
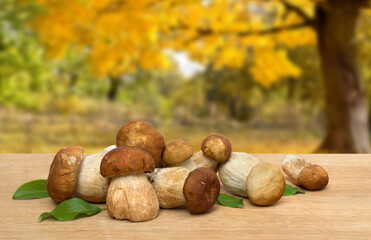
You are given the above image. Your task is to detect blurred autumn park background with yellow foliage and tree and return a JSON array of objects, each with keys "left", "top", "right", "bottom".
[{"left": 0, "top": 0, "right": 371, "bottom": 153}]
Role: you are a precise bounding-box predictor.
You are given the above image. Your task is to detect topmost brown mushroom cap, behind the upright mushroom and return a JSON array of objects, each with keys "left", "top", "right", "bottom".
[{"left": 116, "top": 121, "right": 165, "bottom": 166}]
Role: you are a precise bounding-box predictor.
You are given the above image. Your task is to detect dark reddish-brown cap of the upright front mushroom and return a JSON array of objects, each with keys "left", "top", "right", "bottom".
[{"left": 100, "top": 146, "right": 155, "bottom": 178}]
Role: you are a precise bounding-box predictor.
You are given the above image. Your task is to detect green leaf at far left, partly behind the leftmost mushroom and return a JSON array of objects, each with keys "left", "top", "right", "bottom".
[{"left": 13, "top": 179, "right": 49, "bottom": 199}]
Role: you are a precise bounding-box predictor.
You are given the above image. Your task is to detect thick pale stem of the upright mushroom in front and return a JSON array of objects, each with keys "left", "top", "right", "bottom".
[{"left": 106, "top": 173, "right": 159, "bottom": 222}]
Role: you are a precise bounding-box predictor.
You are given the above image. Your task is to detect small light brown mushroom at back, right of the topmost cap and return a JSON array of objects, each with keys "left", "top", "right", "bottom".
[{"left": 162, "top": 139, "right": 197, "bottom": 171}]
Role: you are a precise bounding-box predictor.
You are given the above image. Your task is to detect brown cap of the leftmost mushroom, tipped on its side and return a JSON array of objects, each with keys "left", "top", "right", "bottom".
[{"left": 46, "top": 146, "right": 84, "bottom": 203}]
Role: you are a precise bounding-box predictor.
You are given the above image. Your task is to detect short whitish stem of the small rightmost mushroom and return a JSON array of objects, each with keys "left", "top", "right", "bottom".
[{"left": 282, "top": 154, "right": 312, "bottom": 185}]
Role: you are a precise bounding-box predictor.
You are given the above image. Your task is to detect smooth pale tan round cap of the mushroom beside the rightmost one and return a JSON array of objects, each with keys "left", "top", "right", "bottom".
[{"left": 246, "top": 163, "right": 286, "bottom": 206}]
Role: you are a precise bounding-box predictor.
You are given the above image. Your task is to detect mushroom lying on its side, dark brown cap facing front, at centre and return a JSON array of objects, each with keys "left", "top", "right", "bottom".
[{"left": 150, "top": 167, "right": 220, "bottom": 213}]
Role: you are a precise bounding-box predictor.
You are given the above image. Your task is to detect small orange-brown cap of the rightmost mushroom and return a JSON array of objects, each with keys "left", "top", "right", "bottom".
[{"left": 298, "top": 165, "right": 329, "bottom": 190}]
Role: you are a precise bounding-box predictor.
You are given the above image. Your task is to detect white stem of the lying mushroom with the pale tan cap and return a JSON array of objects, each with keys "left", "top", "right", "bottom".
[{"left": 219, "top": 152, "right": 261, "bottom": 197}]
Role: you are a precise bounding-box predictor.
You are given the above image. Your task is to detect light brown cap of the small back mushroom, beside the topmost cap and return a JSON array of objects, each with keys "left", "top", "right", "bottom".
[{"left": 162, "top": 139, "right": 193, "bottom": 166}]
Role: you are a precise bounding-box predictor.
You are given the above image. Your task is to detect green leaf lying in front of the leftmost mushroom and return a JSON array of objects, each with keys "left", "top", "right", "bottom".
[{"left": 39, "top": 198, "right": 103, "bottom": 222}]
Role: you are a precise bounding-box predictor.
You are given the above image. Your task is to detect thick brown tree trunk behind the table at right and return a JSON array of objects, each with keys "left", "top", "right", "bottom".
[{"left": 315, "top": 0, "right": 370, "bottom": 153}]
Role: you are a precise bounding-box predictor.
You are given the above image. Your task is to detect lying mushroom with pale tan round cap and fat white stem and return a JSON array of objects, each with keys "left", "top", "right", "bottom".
[{"left": 219, "top": 152, "right": 286, "bottom": 206}]
